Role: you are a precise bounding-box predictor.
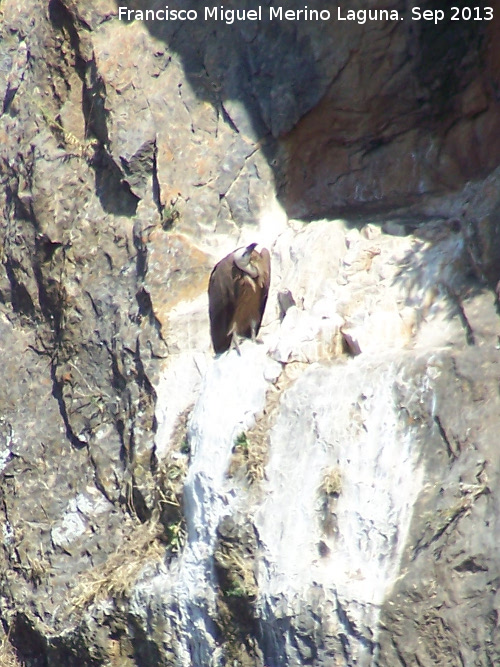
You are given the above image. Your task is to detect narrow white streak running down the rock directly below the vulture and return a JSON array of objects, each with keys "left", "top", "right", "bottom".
[{"left": 175, "top": 342, "right": 281, "bottom": 665}]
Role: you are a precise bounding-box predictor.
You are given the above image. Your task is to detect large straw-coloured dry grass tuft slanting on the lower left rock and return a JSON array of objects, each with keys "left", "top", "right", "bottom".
[{"left": 72, "top": 522, "right": 165, "bottom": 609}]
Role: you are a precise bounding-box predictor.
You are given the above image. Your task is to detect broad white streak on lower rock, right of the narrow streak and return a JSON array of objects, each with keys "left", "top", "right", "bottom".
[{"left": 256, "top": 357, "right": 422, "bottom": 659}]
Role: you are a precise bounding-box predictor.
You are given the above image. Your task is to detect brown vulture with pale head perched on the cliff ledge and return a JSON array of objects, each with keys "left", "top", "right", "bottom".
[{"left": 208, "top": 243, "right": 271, "bottom": 354}]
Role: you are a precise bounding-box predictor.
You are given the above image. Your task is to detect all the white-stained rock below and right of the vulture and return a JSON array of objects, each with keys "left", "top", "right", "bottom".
[{"left": 141, "top": 221, "right": 463, "bottom": 667}]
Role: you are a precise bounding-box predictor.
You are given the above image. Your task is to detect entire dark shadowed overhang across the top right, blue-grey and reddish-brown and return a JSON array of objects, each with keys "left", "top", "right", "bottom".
[{"left": 116, "top": 0, "right": 500, "bottom": 220}]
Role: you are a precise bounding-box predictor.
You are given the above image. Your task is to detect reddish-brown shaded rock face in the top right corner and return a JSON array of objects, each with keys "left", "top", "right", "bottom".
[{"left": 284, "top": 2, "right": 500, "bottom": 217}]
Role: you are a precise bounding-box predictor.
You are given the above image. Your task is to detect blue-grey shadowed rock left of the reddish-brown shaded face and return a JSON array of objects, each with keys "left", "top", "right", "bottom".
[{"left": 116, "top": 0, "right": 334, "bottom": 196}]
